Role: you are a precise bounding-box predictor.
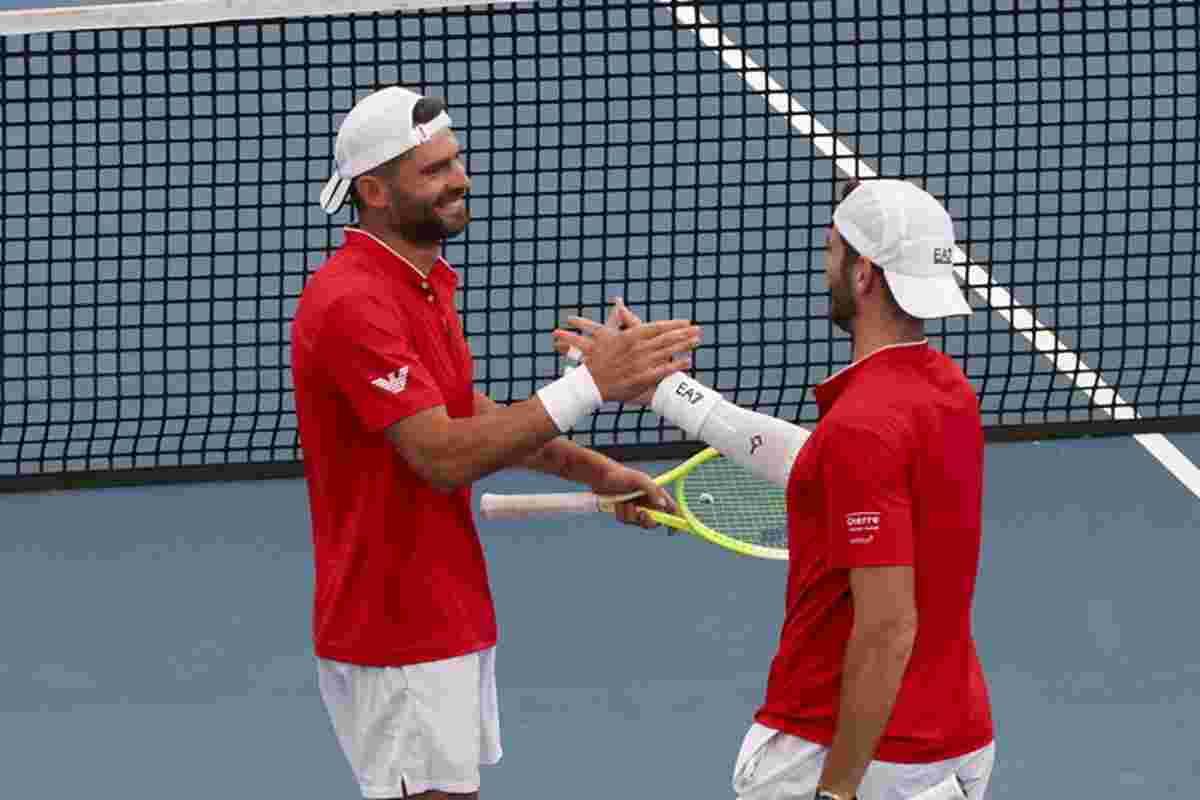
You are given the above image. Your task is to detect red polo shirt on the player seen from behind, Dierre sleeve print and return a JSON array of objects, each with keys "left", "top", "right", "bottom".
[{"left": 756, "top": 342, "right": 992, "bottom": 763}]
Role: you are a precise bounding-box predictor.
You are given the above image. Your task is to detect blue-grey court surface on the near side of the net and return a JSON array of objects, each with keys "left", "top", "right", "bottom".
[{"left": 0, "top": 435, "right": 1200, "bottom": 800}]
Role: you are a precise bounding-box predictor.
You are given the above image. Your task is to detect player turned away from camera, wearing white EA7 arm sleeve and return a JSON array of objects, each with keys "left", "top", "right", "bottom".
[{"left": 556, "top": 180, "right": 995, "bottom": 800}]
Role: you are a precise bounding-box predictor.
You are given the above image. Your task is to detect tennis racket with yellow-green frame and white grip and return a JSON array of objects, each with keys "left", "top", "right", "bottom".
[{"left": 480, "top": 447, "right": 787, "bottom": 560}]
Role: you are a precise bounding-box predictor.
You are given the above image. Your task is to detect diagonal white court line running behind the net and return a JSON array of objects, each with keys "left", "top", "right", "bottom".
[{"left": 659, "top": 0, "right": 1200, "bottom": 497}]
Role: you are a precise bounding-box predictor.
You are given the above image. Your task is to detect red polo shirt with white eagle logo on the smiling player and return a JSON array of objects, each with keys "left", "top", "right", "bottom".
[{"left": 292, "top": 228, "right": 496, "bottom": 666}]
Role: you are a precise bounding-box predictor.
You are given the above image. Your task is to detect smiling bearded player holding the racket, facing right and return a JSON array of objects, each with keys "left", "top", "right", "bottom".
[{"left": 292, "top": 86, "right": 700, "bottom": 798}]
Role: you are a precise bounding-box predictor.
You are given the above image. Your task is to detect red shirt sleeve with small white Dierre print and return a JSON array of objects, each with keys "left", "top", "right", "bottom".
[{"left": 821, "top": 426, "right": 913, "bottom": 569}]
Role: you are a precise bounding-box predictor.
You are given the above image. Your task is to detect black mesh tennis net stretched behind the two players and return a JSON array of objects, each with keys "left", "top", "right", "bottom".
[{"left": 0, "top": 0, "right": 1200, "bottom": 488}]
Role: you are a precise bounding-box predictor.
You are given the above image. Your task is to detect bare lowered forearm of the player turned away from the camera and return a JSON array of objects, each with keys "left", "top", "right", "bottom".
[{"left": 820, "top": 624, "right": 916, "bottom": 798}]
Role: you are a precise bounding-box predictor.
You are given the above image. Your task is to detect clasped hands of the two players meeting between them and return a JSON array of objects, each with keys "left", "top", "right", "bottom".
[{"left": 553, "top": 297, "right": 701, "bottom": 405}]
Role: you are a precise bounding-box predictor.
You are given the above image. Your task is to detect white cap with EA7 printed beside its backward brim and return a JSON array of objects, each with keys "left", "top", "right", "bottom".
[{"left": 833, "top": 179, "right": 971, "bottom": 319}]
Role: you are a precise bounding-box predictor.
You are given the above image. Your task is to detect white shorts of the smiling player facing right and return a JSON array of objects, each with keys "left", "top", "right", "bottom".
[{"left": 317, "top": 648, "right": 502, "bottom": 798}]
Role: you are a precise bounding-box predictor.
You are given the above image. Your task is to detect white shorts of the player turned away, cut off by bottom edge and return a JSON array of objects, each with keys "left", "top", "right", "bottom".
[{"left": 733, "top": 722, "right": 996, "bottom": 800}]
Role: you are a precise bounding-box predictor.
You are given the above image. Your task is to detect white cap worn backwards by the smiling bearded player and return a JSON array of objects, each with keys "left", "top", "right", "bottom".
[{"left": 320, "top": 86, "right": 450, "bottom": 213}]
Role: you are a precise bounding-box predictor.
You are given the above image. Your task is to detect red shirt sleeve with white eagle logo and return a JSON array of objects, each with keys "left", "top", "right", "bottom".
[{"left": 319, "top": 296, "right": 445, "bottom": 431}]
